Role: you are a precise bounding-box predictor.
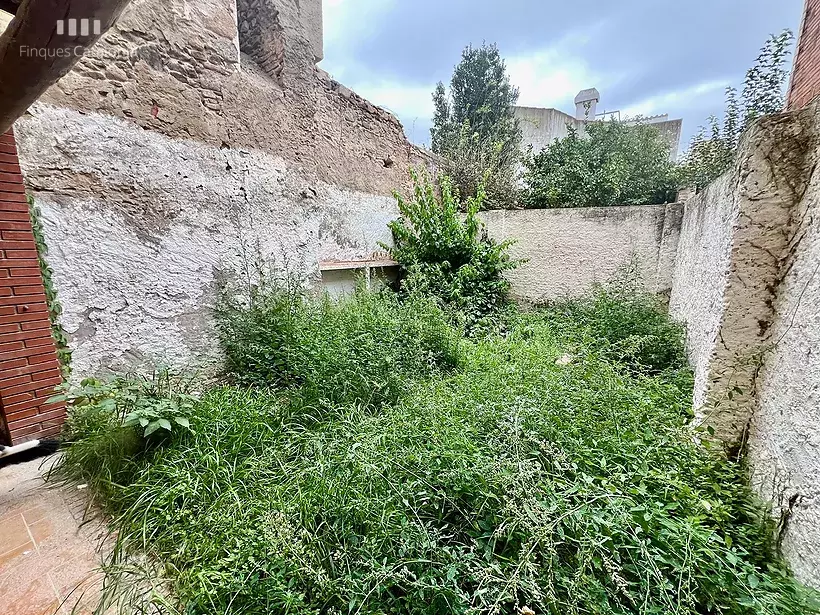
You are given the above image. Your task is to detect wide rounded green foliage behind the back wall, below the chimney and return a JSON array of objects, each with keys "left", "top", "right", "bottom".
[{"left": 523, "top": 121, "right": 677, "bottom": 208}]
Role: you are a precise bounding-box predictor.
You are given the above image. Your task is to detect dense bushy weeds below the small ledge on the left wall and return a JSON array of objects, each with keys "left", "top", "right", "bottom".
[{"left": 217, "top": 281, "right": 459, "bottom": 406}]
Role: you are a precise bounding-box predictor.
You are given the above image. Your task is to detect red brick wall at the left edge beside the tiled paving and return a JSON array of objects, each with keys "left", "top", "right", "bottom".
[{"left": 0, "top": 131, "right": 65, "bottom": 444}]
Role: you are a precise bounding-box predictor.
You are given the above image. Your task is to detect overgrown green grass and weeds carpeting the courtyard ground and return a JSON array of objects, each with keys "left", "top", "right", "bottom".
[{"left": 54, "top": 295, "right": 818, "bottom": 615}]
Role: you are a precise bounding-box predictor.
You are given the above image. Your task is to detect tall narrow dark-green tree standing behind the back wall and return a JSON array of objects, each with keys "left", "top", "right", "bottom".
[{"left": 430, "top": 44, "right": 521, "bottom": 207}]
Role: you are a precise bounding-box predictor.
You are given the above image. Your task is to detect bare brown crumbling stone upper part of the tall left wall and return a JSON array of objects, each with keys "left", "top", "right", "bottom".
[{"left": 20, "top": 0, "right": 430, "bottom": 195}]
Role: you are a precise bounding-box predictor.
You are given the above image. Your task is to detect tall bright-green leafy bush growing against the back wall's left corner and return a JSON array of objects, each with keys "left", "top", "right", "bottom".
[{"left": 384, "top": 173, "right": 518, "bottom": 333}]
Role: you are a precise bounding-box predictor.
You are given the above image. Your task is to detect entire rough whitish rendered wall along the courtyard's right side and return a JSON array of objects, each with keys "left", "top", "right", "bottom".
[{"left": 670, "top": 105, "right": 820, "bottom": 587}]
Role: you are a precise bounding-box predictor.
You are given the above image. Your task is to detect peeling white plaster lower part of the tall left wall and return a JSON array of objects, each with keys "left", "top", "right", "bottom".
[{"left": 16, "top": 105, "right": 396, "bottom": 376}]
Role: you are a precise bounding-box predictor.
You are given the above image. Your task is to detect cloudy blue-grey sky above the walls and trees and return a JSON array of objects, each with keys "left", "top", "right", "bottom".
[{"left": 320, "top": 0, "right": 803, "bottom": 152}]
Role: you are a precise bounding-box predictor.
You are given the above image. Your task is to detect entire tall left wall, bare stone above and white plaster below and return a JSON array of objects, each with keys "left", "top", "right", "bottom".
[{"left": 11, "top": 0, "right": 430, "bottom": 375}]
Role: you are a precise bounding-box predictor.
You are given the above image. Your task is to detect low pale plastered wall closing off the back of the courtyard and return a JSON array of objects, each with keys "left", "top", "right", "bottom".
[{"left": 481, "top": 203, "right": 682, "bottom": 301}]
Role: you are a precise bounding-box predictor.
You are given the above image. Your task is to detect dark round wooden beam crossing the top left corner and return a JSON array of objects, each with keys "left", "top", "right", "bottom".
[{"left": 0, "top": 0, "right": 130, "bottom": 134}]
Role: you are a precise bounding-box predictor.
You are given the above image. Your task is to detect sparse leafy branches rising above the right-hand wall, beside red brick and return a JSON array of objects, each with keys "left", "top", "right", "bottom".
[{"left": 680, "top": 30, "right": 794, "bottom": 190}]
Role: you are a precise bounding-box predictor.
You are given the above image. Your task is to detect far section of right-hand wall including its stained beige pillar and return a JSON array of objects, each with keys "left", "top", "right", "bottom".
[{"left": 670, "top": 112, "right": 816, "bottom": 448}]
